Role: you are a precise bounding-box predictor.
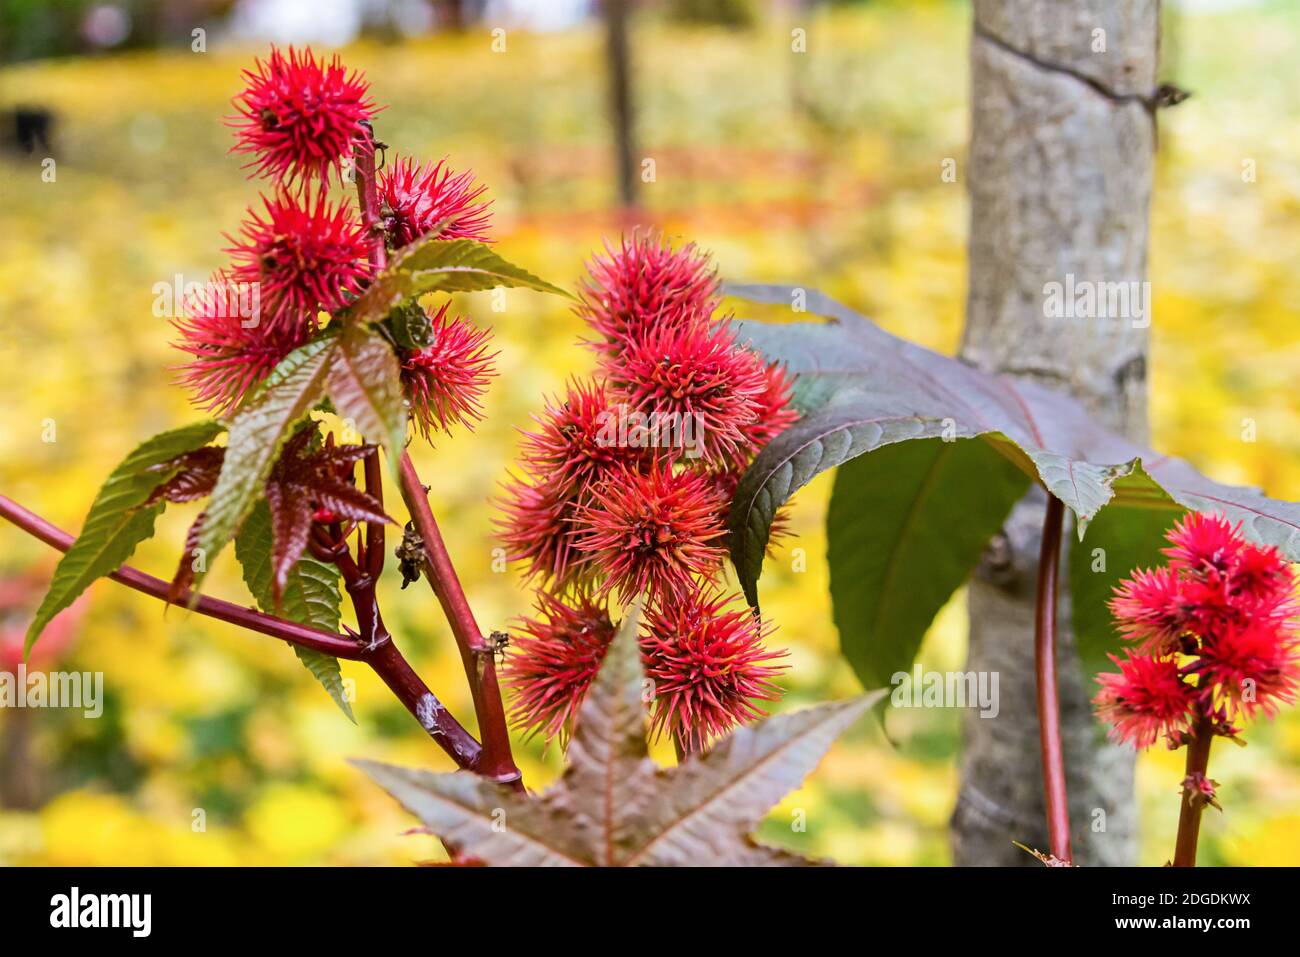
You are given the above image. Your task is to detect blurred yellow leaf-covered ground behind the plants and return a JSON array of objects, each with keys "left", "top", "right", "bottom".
[{"left": 0, "top": 4, "right": 1300, "bottom": 865}]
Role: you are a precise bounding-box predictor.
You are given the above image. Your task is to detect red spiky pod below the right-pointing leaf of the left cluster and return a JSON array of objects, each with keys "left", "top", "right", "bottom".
[{"left": 402, "top": 302, "right": 497, "bottom": 438}]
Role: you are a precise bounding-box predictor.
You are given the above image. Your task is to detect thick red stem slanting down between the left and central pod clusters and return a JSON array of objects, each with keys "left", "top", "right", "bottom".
[{"left": 399, "top": 452, "right": 523, "bottom": 789}]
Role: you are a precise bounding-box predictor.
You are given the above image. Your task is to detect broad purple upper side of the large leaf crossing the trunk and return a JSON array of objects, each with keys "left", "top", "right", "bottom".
[{"left": 727, "top": 280, "right": 1300, "bottom": 613}]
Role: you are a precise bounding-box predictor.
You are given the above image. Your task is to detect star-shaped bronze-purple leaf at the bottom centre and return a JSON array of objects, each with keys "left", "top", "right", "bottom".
[{"left": 354, "top": 611, "right": 885, "bottom": 867}]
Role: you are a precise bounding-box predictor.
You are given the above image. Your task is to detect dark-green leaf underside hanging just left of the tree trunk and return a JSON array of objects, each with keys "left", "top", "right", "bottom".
[{"left": 826, "top": 438, "right": 1030, "bottom": 688}]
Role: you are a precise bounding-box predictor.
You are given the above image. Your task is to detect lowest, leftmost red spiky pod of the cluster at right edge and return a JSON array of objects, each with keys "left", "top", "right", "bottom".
[{"left": 1092, "top": 650, "right": 1196, "bottom": 748}]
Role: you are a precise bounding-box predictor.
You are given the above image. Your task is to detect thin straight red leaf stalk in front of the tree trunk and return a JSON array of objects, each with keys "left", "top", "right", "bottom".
[{"left": 1034, "top": 492, "right": 1071, "bottom": 862}]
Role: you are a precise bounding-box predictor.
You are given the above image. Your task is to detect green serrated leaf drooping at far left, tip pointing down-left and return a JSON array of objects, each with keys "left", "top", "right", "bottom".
[{"left": 25, "top": 421, "right": 224, "bottom": 653}]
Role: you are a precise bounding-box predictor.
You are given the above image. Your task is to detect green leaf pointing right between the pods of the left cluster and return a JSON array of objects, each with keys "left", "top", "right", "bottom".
[{"left": 348, "top": 239, "right": 572, "bottom": 322}]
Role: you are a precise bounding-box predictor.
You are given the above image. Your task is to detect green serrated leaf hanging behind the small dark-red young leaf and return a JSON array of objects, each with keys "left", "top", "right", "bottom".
[{"left": 235, "top": 502, "right": 356, "bottom": 724}]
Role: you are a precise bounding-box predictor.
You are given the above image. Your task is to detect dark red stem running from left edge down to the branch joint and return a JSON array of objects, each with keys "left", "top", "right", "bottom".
[{"left": 0, "top": 495, "right": 482, "bottom": 770}]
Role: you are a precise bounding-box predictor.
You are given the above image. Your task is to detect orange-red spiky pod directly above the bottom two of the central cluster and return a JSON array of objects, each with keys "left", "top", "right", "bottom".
[{"left": 573, "top": 462, "right": 724, "bottom": 602}]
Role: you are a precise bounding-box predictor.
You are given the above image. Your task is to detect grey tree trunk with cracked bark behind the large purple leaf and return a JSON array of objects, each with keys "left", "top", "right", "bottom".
[{"left": 952, "top": 0, "right": 1160, "bottom": 865}]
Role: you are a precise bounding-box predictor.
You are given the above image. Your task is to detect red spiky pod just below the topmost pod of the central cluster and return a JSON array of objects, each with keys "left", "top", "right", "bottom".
[{"left": 601, "top": 324, "right": 767, "bottom": 464}]
